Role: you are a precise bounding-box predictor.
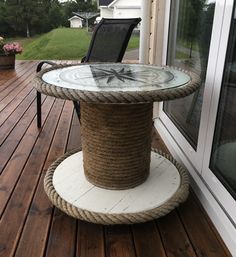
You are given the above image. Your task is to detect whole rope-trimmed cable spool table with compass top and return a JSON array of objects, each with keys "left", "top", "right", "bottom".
[{"left": 34, "top": 63, "right": 200, "bottom": 224}]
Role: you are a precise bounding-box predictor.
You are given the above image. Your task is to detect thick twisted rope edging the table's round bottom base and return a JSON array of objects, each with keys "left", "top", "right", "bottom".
[{"left": 44, "top": 149, "right": 189, "bottom": 225}]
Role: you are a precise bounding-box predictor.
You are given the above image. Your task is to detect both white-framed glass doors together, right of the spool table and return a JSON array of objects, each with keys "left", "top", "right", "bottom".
[{"left": 158, "top": 0, "right": 236, "bottom": 224}]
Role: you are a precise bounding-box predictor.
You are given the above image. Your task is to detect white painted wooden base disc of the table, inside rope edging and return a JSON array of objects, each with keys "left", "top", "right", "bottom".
[{"left": 53, "top": 152, "right": 181, "bottom": 214}]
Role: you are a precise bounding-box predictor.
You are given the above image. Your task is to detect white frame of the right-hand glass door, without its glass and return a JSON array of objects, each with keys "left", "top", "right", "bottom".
[{"left": 202, "top": 0, "right": 236, "bottom": 224}]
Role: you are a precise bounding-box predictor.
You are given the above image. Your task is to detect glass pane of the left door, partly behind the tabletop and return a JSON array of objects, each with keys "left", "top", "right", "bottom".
[{"left": 164, "top": 0, "right": 215, "bottom": 149}]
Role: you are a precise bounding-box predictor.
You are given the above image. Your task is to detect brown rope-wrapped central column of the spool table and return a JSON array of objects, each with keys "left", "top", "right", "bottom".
[{"left": 81, "top": 103, "right": 153, "bottom": 190}]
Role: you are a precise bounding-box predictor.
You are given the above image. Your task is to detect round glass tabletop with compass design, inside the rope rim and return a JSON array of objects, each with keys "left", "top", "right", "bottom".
[{"left": 42, "top": 63, "right": 191, "bottom": 92}]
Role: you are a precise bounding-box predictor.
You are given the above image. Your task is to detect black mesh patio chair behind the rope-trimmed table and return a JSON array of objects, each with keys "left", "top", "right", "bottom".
[{"left": 36, "top": 18, "right": 141, "bottom": 128}]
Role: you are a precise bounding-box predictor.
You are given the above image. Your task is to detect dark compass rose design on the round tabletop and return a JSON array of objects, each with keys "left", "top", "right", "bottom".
[{"left": 59, "top": 63, "right": 181, "bottom": 91}]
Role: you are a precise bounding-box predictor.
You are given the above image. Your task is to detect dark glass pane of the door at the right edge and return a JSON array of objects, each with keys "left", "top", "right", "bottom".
[{"left": 210, "top": 6, "right": 236, "bottom": 199}]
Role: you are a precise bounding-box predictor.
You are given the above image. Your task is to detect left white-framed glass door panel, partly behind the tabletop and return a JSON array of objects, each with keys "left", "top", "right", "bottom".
[{"left": 160, "top": 0, "right": 225, "bottom": 173}]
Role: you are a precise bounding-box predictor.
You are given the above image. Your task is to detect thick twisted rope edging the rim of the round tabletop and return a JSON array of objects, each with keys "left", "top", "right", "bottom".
[{"left": 34, "top": 64, "right": 200, "bottom": 103}]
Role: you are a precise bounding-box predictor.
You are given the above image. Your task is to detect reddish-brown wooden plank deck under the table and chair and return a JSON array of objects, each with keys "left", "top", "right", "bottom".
[{"left": 0, "top": 61, "right": 231, "bottom": 257}]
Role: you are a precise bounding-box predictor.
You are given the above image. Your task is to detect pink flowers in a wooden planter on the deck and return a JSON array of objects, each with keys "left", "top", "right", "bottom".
[{"left": 0, "top": 37, "right": 23, "bottom": 70}]
